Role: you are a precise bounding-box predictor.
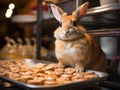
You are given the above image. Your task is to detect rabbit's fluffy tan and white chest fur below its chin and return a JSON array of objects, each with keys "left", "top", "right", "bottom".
[{"left": 55, "top": 39, "right": 90, "bottom": 67}]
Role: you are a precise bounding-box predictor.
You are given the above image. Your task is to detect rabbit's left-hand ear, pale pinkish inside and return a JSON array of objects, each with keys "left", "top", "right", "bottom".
[{"left": 51, "top": 4, "right": 67, "bottom": 22}]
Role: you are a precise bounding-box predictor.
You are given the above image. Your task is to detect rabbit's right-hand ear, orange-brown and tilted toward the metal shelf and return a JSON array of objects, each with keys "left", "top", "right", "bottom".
[{"left": 73, "top": 2, "right": 89, "bottom": 19}]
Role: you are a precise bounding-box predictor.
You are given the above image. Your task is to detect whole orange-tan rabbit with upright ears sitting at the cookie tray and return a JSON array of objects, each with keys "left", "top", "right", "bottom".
[{"left": 50, "top": 2, "right": 106, "bottom": 72}]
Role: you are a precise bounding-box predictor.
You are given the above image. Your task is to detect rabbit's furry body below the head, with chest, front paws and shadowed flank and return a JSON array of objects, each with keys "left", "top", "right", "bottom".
[{"left": 55, "top": 34, "right": 106, "bottom": 71}]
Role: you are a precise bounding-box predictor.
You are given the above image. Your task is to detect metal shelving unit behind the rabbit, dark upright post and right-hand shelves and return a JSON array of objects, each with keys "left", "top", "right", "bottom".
[{"left": 36, "top": 0, "right": 120, "bottom": 59}]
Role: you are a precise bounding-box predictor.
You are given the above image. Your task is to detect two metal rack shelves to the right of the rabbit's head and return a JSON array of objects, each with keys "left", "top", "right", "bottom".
[{"left": 86, "top": 3, "right": 120, "bottom": 37}]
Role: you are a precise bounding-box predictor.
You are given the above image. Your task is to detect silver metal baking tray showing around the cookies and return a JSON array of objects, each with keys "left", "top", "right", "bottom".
[{"left": 0, "top": 59, "right": 108, "bottom": 90}]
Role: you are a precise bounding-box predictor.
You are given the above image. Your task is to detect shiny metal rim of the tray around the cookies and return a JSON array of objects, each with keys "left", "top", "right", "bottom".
[{"left": 0, "top": 59, "right": 109, "bottom": 89}]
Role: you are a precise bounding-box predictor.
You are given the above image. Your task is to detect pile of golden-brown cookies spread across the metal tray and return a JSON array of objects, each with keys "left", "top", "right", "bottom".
[{"left": 0, "top": 60, "right": 99, "bottom": 85}]
